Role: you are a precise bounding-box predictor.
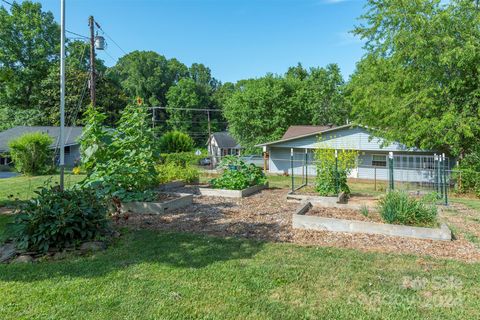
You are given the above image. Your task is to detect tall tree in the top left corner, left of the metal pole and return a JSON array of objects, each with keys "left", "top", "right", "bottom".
[{"left": 0, "top": 1, "right": 60, "bottom": 126}]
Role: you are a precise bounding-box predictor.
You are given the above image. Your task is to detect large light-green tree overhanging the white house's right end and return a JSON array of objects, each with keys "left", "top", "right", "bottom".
[{"left": 348, "top": 0, "right": 480, "bottom": 157}]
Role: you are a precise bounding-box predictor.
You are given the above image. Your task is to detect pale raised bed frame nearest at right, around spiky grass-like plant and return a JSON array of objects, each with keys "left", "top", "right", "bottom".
[{"left": 292, "top": 202, "right": 452, "bottom": 240}]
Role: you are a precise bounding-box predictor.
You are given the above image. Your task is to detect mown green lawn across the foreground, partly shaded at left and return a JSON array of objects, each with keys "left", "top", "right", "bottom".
[{"left": 0, "top": 231, "right": 480, "bottom": 319}]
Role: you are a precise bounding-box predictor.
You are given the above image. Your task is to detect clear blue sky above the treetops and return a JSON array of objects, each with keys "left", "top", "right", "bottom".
[{"left": 8, "top": 0, "right": 364, "bottom": 82}]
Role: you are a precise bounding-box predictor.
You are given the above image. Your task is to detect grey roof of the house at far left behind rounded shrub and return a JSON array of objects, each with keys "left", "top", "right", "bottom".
[{"left": 0, "top": 126, "right": 83, "bottom": 152}]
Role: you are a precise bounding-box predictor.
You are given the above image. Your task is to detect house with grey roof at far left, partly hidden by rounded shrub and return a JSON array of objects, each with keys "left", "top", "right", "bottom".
[{"left": 0, "top": 126, "right": 83, "bottom": 167}]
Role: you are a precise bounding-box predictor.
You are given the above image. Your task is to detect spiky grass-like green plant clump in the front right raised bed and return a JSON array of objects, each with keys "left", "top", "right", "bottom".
[{"left": 379, "top": 191, "right": 437, "bottom": 226}]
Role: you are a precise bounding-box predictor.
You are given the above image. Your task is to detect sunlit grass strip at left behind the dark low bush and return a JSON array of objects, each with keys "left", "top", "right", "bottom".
[{"left": 0, "top": 174, "right": 85, "bottom": 206}]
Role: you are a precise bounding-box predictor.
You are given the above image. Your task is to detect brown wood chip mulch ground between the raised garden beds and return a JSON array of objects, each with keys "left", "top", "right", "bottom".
[{"left": 119, "top": 187, "right": 480, "bottom": 262}]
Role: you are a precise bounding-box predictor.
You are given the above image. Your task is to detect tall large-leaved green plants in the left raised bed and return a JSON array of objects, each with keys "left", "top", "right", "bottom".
[{"left": 82, "top": 101, "right": 158, "bottom": 199}]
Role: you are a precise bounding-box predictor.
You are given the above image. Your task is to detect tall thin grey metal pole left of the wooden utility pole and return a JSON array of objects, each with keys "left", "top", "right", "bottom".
[{"left": 58, "top": 0, "right": 65, "bottom": 191}]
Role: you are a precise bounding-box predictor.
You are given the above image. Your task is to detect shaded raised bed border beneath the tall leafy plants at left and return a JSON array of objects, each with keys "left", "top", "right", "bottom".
[{"left": 122, "top": 193, "right": 193, "bottom": 214}]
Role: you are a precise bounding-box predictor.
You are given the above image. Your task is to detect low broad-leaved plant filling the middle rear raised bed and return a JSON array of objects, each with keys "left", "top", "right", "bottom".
[{"left": 210, "top": 156, "right": 267, "bottom": 190}]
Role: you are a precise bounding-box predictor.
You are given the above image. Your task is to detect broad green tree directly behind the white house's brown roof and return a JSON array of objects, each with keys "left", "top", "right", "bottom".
[{"left": 220, "top": 64, "right": 349, "bottom": 148}]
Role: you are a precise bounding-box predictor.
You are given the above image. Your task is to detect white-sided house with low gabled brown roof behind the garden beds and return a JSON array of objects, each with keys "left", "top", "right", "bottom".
[{"left": 257, "top": 124, "right": 452, "bottom": 182}]
